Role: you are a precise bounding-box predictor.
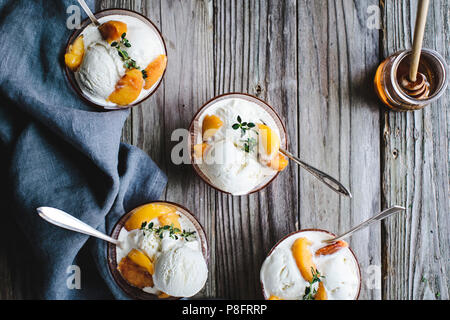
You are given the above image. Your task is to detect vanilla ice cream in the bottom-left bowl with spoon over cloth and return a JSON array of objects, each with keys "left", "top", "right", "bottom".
[{"left": 116, "top": 212, "right": 208, "bottom": 297}]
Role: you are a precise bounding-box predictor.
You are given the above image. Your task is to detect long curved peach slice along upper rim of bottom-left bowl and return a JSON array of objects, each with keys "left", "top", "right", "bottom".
[{"left": 125, "top": 203, "right": 177, "bottom": 231}]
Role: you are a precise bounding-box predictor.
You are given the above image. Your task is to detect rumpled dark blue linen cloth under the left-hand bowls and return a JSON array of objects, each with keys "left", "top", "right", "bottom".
[{"left": 0, "top": 0, "right": 167, "bottom": 299}]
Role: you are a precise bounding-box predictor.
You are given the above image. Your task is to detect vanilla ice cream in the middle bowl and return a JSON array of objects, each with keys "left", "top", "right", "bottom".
[{"left": 197, "top": 98, "right": 280, "bottom": 195}]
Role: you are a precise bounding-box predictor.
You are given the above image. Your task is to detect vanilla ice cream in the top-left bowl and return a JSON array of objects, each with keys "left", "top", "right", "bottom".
[{"left": 75, "top": 15, "right": 166, "bottom": 107}]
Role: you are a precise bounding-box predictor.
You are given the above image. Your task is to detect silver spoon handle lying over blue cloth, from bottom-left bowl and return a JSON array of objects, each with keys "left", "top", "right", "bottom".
[{"left": 36, "top": 207, "right": 122, "bottom": 248}]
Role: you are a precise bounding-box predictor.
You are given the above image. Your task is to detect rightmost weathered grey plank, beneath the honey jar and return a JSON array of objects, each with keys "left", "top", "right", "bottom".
[{"left": 382, "top": 0, "right": 450, "bottom": 299}]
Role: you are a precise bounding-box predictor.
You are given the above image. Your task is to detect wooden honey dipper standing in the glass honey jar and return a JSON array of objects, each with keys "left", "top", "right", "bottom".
[{"left": 400, "top": 0, "right": 430, "bottom": 99}]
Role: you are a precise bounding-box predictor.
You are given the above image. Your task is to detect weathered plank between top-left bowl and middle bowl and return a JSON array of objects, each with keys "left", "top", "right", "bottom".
[{"left": 156, "top": 1, "right": 216, "bottom": 297}]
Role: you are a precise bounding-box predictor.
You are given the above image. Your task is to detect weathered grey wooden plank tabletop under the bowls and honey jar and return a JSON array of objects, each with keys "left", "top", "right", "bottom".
[{"left": 0, "top": 0, "right": 450, "bottom": 299}]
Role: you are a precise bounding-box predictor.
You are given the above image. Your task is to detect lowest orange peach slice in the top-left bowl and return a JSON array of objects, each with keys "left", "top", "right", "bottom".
[{"left": 108, "top": 69, "right": 144, "bottom": 106}]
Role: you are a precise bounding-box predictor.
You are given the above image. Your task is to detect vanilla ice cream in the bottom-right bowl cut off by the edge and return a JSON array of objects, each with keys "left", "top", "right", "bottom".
[{"left": 260, "top": 231, "right": 360, "bottom": 300}]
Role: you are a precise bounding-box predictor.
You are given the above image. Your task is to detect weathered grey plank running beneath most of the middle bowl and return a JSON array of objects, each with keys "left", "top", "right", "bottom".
[{"left": 214, "top": 0, "right": 298, "bottom": 299}]
